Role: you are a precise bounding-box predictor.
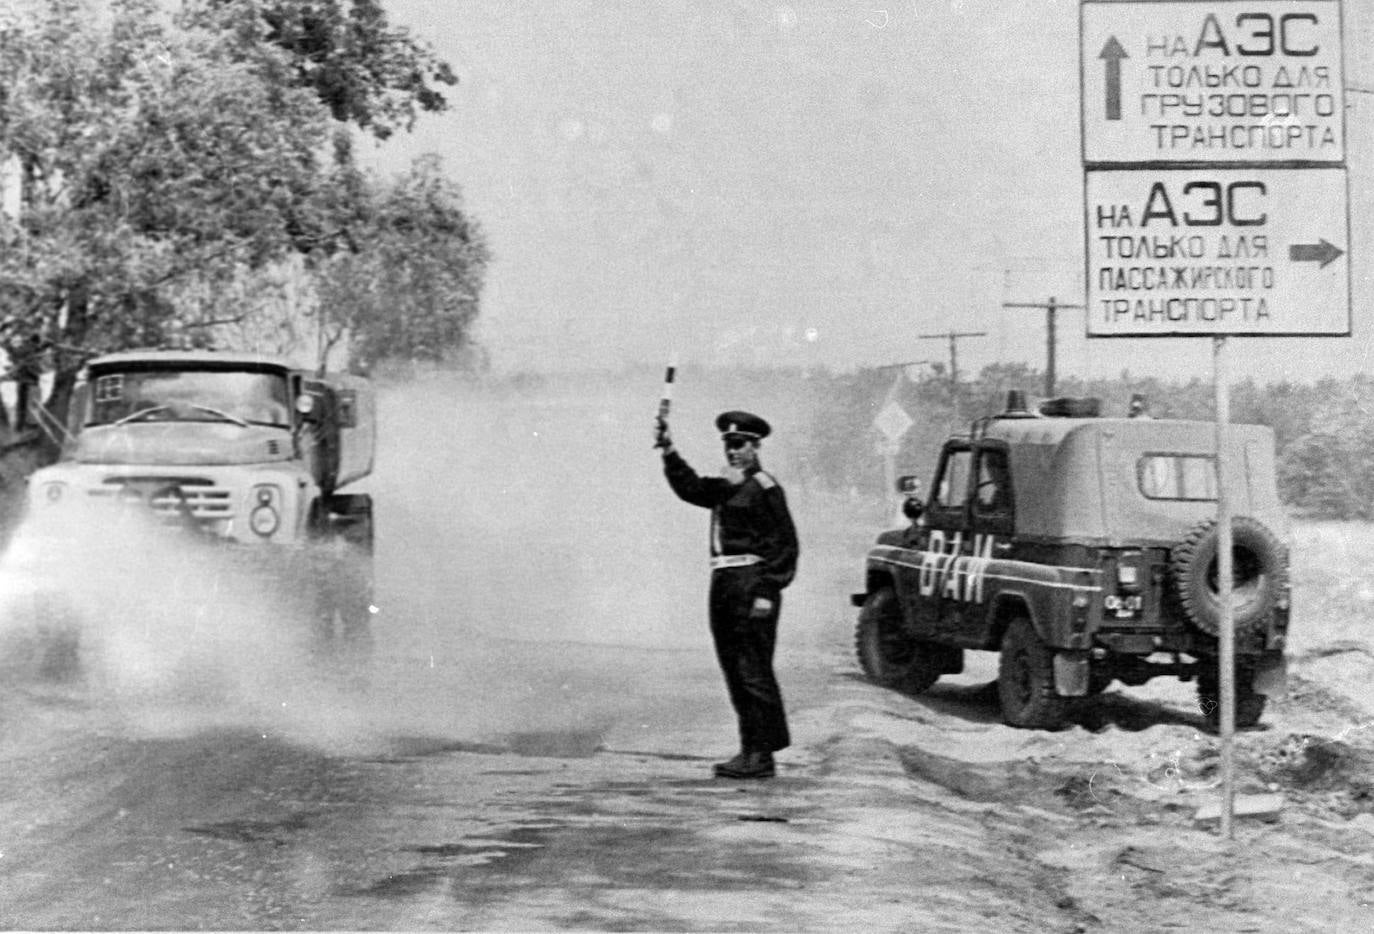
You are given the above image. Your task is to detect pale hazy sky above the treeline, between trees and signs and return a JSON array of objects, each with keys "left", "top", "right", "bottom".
[{"left": 362, "top": 0, "right": 1374, "bottom": 379}]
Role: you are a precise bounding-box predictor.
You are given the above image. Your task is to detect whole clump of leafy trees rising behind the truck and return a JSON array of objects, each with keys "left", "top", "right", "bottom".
[{"left": 0, "top": 0, "right": 486, "bottom": 456}]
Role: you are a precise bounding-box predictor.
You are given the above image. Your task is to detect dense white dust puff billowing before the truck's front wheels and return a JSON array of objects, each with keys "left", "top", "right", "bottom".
[{"left": 0, "top": 503, "right": 343, "bottom": 732}]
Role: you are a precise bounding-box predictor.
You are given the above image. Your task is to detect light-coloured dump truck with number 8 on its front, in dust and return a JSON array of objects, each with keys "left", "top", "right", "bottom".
[{"left": 0, "top": 350, "right": 375, "bottom": 670}]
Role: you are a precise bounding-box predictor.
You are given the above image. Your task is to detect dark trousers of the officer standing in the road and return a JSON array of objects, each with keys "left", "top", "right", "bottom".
[{"left": 710, "top": 567, "right": 791, "bottom": 753}]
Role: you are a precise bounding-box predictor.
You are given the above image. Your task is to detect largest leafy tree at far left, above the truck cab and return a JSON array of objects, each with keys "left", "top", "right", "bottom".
[{"left": 0, "top": 0, "right": 335, "bottom": 442}]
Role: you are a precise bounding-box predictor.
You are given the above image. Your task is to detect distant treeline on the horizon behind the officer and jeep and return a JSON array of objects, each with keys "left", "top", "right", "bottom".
[{"left": 507, "top": 364, "right": 1374, "bottom": 519}]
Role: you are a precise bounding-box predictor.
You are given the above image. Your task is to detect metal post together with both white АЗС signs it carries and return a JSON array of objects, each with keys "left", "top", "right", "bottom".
[{"left": 1079, "top": 0, "right": 1351, "bottom": 838}]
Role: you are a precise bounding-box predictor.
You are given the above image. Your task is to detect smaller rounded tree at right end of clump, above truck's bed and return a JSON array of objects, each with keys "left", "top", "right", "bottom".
[{"left": 317, "top": 157, "right": 491, "bottom": 372}]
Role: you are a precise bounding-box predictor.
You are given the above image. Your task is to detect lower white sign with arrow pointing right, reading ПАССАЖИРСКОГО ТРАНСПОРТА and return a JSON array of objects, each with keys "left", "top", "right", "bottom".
[{"left": 1084, "top": 166, "right": 1351, "bottom": 337}]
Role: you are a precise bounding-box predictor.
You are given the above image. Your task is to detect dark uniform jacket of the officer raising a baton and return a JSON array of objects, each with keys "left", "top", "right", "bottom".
[{"left": 664, "top": 451, "right": 798, "bottom": 591}]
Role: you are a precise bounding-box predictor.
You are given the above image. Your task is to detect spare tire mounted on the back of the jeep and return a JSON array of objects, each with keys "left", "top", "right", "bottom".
[{"left": 1169, "top": 515, "right": 1287, "bottom": 636}]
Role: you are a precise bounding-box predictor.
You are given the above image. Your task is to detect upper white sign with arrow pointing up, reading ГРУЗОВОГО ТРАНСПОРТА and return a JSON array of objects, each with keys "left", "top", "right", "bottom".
[{"left": 1079, "top": 0, "right": 1345, "bottom": 166}]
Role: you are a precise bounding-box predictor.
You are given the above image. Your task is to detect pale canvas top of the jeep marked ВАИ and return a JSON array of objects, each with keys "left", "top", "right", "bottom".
[{"left": 961, "top": 418, "right": 1287, "bottom": 545}]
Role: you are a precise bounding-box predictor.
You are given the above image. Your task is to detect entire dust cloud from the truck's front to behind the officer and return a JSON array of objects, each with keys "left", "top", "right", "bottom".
[{"left": 0, "top": 375, "right": 871, "bottom": 751}]
